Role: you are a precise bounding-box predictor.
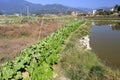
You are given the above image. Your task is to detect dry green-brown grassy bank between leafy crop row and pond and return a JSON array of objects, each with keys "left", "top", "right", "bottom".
[{"left": 60, "top": 23, "right": 120, "bottom": 80}]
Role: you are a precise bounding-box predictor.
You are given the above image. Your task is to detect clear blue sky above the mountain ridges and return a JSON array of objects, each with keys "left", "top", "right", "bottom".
[{"left": 27, "top": 0, "right": 120, "bottom": 8}]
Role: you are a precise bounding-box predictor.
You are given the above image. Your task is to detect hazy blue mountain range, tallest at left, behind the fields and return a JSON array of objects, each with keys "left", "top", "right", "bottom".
[{"left": 0, "top": 0, "right": 81, "bottom": 14}]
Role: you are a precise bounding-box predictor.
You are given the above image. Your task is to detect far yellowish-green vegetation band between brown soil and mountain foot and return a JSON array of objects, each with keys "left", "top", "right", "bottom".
[{"left": 0, "top": 15, "right": 78, "bottom": 25}]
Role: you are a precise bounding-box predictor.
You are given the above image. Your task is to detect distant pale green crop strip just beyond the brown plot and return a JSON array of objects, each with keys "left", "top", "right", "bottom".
[{"left": 0, "top": 16, "right": 79, "bottom": 25}]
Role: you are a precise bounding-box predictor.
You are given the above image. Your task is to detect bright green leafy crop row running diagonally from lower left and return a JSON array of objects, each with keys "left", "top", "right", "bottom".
[{"left": 0, "top": 21, "right": 84, "bottom": 80}]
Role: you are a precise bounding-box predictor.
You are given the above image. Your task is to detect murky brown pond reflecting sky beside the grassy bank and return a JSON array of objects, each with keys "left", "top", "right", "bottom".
[{"left": 90, "top": 22, "right": 120, "bottom": 69}]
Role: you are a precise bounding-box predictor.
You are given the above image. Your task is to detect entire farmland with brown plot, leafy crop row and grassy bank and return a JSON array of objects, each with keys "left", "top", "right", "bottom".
[{"left": 0, "top": 17, "right": 120, "bottom": 80}]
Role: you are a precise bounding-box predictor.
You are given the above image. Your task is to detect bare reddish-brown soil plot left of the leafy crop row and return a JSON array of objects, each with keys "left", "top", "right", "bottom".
[{"left": 0, "top": 21, "right": 63, "bottom": 66}]
